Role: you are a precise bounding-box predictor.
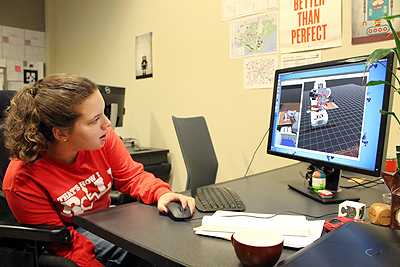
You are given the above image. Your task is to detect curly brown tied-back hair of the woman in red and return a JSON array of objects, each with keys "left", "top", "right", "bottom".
[{"left": 4, "top": 73, "right": 98, "bottom": 164}]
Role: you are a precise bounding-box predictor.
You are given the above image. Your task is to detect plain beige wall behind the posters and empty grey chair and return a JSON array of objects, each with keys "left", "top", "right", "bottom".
[{"left": 46, "top": 0, "right": 399, "bottom": 193}]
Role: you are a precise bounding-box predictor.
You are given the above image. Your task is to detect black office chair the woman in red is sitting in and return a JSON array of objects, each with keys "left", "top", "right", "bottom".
[{"left": 0, "top": 90, "right": 78, "bottom": 267}]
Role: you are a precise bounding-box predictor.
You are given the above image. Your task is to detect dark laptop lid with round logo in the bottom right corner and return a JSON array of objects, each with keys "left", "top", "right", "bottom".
[{"left": 279, "top": 222, "right": 400, "bottom": 267}]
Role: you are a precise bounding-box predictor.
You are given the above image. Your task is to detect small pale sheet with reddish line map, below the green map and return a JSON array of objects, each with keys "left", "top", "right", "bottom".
[{"left": 244, "top": 56, "right": 278, "bottom": 89}]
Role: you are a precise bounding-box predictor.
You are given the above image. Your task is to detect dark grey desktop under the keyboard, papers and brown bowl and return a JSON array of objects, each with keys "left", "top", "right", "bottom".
[{"left": 72, "top": 163, "right": 388, "bottom": 266}]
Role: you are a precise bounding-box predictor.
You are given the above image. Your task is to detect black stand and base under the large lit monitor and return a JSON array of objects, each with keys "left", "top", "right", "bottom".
[{"left": 288, "top": 167, "right": 360, "bottom": 204}]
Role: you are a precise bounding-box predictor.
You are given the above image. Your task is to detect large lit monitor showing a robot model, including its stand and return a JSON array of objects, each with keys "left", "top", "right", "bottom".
[{"left": 267, "top": 53, "right": 393, "bottom": 203}]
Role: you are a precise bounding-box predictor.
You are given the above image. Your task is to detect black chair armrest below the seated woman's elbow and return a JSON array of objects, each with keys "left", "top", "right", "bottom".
[{"left": 0, "top": 223, "right": 71, "bottom": 243}]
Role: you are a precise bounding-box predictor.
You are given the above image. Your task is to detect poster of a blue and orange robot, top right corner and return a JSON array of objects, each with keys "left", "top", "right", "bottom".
[{"left": 351, "top": 0, "right": 400, "bottom": 44}]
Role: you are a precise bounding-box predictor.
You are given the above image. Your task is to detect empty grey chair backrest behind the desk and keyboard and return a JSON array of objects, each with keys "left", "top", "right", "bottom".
[{"left": 172, "top": 116, "right": 218, "bottom": 195}]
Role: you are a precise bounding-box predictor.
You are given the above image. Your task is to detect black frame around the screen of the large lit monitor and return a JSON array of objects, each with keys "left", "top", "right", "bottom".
[{"left": 267, "top": 52, "right": 395, "bottom": 177}]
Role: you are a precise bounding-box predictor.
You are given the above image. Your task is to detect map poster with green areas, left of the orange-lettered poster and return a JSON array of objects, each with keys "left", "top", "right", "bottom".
[{"left": 231, "top": 12, "right": 278, "bottom": 58}]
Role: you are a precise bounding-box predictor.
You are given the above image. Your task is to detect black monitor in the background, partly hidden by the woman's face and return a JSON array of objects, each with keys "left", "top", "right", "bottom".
[{"left": 97, "top": 85, "right": 125, "bottom": 129}]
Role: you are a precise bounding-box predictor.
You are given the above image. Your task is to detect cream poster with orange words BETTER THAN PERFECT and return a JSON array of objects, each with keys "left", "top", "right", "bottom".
[{"left": 279, "top": 0, "right": 342, "bottom": 53}]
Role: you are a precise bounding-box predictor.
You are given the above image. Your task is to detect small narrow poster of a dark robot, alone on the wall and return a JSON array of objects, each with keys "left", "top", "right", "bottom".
[{"left": 136, "top": 32, "right": 153, "bottom": 79}]
